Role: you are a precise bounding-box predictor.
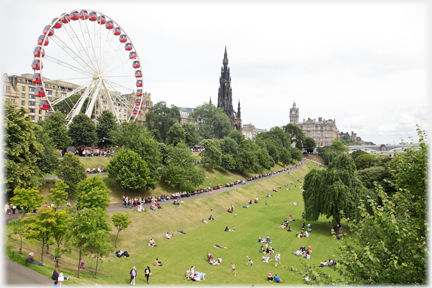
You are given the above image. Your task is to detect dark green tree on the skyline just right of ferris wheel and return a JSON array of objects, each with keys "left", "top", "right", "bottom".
[{"left": 145, "top": 101, "right": 181, "bottom": 143}]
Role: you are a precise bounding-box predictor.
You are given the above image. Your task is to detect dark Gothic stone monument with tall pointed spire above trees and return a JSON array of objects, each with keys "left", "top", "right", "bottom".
[{"left": 218, "top": 47, "right": 242, "bottom": 131}]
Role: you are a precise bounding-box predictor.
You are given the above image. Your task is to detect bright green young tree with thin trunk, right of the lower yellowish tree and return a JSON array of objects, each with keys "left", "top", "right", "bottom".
[{"left": 66, "top": 208, "right": 109, "bottom": 278}]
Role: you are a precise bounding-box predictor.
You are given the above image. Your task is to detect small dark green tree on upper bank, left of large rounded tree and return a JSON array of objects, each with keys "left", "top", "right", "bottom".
[{"left": 56, "top": 153, "right": 87, "bottom": 198}]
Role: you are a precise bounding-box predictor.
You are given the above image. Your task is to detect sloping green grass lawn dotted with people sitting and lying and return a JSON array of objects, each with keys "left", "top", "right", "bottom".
[{"left": 5, "top": 163, "right": 336, "bottom": 285}]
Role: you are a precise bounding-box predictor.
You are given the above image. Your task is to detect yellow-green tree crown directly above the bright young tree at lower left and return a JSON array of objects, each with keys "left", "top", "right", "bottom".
[{"left": 77, "top": 176, "right": 111, "bottom": 214}]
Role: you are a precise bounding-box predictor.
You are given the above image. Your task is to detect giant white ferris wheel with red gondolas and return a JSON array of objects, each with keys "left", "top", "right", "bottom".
[{"left": 32, "top": 9, "right": 143, "bottom": 125}]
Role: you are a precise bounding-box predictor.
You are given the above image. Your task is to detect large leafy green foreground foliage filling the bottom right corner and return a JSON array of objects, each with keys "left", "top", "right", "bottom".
[{"left": 291, "top": 128, "right": 429, "bottom": 285}]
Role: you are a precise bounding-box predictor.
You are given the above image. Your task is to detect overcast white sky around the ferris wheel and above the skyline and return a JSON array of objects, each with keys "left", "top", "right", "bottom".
[{"left": 2, "top": 0, "right": 431, "bottom": 144}]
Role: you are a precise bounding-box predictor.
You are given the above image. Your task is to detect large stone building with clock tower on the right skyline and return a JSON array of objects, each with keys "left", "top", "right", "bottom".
[{"left": 290, "top": 102, "right": 339, "bottom": 147}]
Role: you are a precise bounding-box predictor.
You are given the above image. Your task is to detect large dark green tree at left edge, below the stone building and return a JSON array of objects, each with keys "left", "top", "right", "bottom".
[{"left": 5, "top": 102, "right": 43, "bottom": 193}]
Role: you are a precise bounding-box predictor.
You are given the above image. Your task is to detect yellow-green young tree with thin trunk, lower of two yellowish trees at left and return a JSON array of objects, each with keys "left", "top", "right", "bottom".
[{"left": 21, "top": 207, "right": 56, "bottom": 264}]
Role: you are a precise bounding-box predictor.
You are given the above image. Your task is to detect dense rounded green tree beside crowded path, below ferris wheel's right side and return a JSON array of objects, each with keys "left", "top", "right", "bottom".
[{"left": 107, "top": 148, "right": 150, "bottom": 190}]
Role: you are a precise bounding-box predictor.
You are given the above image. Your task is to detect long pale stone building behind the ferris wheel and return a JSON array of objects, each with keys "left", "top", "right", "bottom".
[{"left": 3, "top": 73, "right": 153, "bottom": 122}]
